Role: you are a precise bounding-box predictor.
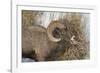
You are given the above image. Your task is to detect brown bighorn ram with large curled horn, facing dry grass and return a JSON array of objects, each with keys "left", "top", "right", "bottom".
[{"left": 22, "top": 21, "right": 65, "bottom": 61}]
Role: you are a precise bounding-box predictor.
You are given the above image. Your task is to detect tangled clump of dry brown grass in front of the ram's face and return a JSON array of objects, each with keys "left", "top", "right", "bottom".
[{"left": 47, "top": 15, "right": 89, "bottom": 61}]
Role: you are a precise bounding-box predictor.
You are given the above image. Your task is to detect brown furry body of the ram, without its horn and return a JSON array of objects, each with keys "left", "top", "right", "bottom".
[{"left": 22, "top": 26, "right": 57, "bottom": 61}]
